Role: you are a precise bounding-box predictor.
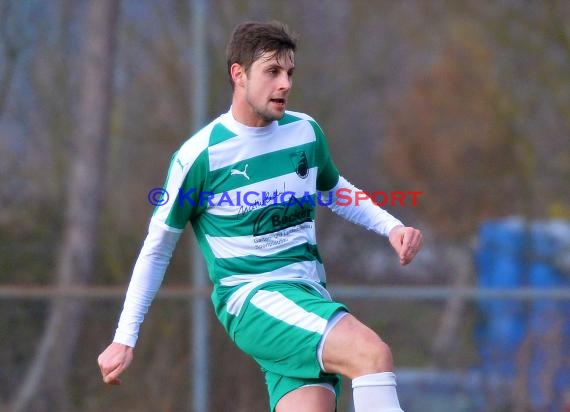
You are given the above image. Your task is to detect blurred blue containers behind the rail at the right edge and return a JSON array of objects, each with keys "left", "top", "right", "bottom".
[{"left": 475, "top": 219, "right": 570, "bottom": 412}]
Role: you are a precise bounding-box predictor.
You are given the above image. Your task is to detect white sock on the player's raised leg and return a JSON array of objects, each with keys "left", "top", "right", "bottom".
[{"left": 352, "top": 372, "right": 403, "bottom": 412}]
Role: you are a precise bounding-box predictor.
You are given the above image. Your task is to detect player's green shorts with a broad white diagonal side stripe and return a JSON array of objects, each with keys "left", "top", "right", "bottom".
[{"left": 233, "top": 282, "right": 348, "bottom": 411}]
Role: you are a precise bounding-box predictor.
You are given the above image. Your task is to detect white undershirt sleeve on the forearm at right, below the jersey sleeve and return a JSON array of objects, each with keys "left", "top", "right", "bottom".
[{"left": 323, "top": 176, "right": 402, "bottom": 236}]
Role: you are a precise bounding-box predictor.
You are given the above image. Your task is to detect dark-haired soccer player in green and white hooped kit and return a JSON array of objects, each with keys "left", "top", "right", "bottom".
[{"left": 98, "top": 22, "right": 422, "bottom": 412}]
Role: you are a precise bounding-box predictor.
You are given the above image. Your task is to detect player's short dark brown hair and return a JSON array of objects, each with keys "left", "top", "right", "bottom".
[{"left": 226, "top": 21, "right": 298, "bottom": 88}]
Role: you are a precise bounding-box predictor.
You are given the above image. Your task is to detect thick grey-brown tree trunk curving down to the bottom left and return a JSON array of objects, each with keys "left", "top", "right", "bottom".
[{"left": 12, "top": 0, "right": 119, "bottom": 412}]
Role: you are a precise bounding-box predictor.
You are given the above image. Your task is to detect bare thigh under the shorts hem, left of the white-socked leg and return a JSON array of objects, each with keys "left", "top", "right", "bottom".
[{"left": 275, "top": 385, "right": 336, "bottom": 412}]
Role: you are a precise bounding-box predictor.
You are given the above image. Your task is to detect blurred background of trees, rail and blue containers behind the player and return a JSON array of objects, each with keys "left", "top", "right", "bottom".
[{"left": 0, "top": 0, "right": 570, "bottom": 412}]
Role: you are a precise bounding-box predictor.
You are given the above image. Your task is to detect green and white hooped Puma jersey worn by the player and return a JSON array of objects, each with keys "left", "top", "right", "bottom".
[{"left": 152, "top": 111, "right": 339, "bottom": 328}]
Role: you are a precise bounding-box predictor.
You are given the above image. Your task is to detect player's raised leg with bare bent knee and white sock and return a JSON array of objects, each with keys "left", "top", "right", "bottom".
[{"left": 322, "top": 314, "right": 402, "bottom": 412}]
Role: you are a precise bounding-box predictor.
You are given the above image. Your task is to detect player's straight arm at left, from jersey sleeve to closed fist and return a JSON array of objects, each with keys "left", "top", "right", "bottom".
[{"left": 98, "top": 141, "right": 207, "bottom": 385}]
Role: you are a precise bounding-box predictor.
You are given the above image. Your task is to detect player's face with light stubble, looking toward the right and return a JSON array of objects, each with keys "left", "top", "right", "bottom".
[{"left": 240, "top": 51, "right": 295, "bottom": 126}]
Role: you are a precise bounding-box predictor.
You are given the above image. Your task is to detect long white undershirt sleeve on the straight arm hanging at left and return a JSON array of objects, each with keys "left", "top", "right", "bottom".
[{"left": 113, "top": 221, "right": 181, "bottom": 347}]
